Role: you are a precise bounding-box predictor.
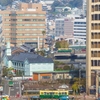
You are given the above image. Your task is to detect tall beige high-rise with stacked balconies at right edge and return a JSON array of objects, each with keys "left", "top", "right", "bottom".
[{"left": 86, "top": 0, "right": 100, "bottom": 92}]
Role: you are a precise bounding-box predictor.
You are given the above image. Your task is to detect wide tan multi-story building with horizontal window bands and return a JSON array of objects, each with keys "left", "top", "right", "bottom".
[{"left": 0, "top": 3, "right": 46, "bottom": 48}]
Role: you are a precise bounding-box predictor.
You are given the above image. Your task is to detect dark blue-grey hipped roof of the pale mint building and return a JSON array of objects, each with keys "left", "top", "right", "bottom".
[{"left": 11, "top": 52, "right": 53, "bottom": 63}]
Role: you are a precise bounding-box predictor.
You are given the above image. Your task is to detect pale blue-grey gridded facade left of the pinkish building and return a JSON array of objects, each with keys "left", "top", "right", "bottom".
[{"left": 55, "top": 18, "right": 64, "bottom": 36}]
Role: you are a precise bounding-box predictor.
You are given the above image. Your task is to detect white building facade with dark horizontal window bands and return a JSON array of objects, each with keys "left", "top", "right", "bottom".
[{"left": 74, "top": 18, "right": 86, "bottom": 40}]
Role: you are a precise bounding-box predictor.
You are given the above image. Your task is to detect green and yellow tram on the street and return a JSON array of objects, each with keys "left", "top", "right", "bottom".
[{"left": 39, "top": 90, "right": 69, "bottom": 99}]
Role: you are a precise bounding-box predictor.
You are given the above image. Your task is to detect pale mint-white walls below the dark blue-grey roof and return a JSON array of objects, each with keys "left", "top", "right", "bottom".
[{"left": 4, "top": 59, "right": 54, "bottom": 76}]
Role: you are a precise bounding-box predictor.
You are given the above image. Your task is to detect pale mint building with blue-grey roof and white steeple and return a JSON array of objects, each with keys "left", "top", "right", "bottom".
[{"left": 2, "top": 43, "right": 54, "bottom": 76}]
